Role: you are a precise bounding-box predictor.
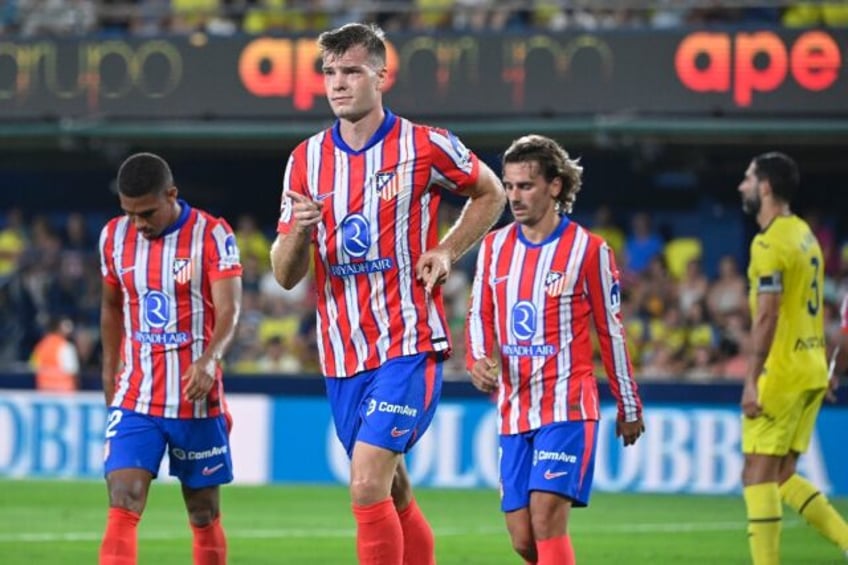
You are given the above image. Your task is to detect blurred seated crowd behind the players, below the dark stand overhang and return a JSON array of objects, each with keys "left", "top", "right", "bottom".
[{"left": 0, "top": 204, "right": 848, "bottom": 381}]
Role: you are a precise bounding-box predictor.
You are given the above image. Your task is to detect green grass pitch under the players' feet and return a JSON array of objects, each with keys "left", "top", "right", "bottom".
[{"left": 0, "top": 481, "right": 848, "bottom": 565}]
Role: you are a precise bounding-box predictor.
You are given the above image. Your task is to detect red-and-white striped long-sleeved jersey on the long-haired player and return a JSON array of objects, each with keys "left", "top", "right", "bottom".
[{"left": 466, "top": 217, "right": 642, "bottom": 434}]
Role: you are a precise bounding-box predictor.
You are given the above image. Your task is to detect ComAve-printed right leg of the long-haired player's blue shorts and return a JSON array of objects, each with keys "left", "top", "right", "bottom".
[{"left": 530, "top": 420, "right": 598, "bottom": 506}]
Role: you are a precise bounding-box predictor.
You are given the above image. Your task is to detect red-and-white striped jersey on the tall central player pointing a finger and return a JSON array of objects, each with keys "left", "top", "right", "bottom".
[{"left": 277, "top": 112, "right": 479, "bottom": 377}]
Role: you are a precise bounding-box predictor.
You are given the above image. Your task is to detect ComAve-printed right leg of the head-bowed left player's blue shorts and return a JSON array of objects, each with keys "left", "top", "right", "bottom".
[{"left": 163, "top": 414, "right": 233, "bottom": 489}]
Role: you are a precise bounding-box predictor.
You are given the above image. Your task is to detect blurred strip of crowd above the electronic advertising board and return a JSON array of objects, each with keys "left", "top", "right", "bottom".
[{"left": 0, "top": 0, "right": 848, "bottom": 37}]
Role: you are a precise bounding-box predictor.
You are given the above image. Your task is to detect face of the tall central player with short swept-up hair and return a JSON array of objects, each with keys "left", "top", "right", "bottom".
[{"left": 323, "top": 45, "right": 386, "bottom": 122}]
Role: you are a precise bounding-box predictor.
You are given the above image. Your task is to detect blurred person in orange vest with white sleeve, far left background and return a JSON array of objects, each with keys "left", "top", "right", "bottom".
[{"left": 31, "top": 317, "right": 79, "bottom": 392}]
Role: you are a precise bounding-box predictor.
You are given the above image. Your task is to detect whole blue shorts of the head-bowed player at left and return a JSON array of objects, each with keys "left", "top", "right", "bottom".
[{"left": 103, "top": 408, "right": 233, "bottom": 489}]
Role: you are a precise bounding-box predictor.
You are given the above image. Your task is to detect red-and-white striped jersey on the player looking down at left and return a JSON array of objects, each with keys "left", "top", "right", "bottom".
[{"left": 100, "top": 200, "right": 242, "bottom": 418}]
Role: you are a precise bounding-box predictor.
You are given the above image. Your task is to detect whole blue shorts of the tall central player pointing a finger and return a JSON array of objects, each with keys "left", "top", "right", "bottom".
[{"left": 325, "top": 353, "right": 444, "bottom": 457}]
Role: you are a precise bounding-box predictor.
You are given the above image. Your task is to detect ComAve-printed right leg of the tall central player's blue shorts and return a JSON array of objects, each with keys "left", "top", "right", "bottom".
[{"left": 356, "top": 353, "right": 444, "bottom": 453}]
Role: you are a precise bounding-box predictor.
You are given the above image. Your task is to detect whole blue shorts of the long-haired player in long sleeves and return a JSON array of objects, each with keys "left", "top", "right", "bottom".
[{"left": 499, "top": 420, "right": 598, "bottom": 512}]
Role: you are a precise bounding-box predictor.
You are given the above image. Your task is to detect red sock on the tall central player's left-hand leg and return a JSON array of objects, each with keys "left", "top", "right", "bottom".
[{"left": 353, "top": 497, "right": 403, "bottom": 565}]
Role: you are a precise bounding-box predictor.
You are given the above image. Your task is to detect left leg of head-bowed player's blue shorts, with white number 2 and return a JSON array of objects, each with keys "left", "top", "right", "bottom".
[{"left": 103, "top": 408, "right": 167, "bottom": 478}]
